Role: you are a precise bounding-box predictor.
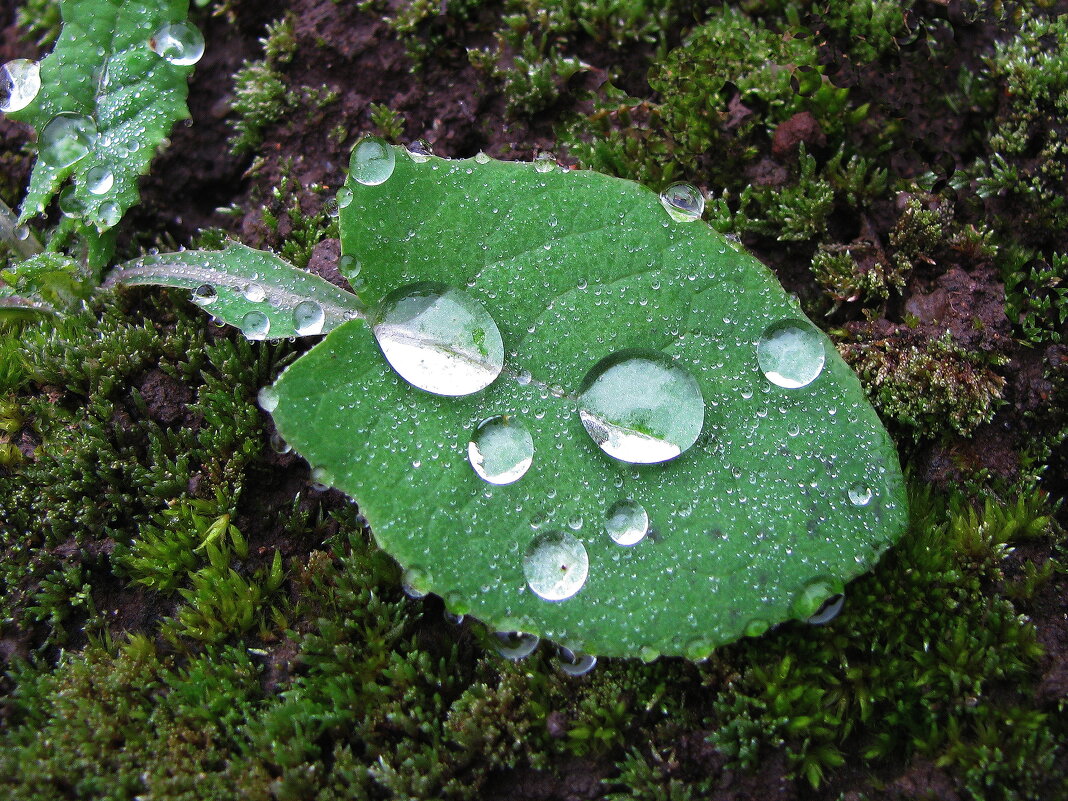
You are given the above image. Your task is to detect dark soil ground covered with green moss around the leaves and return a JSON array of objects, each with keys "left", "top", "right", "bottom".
[{"left": 0, "top": 0, "right": 1068, "bottom": 801}]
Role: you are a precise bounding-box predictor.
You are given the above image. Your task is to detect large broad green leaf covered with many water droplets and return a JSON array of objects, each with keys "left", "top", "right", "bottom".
[{"left": 262, "top": 145, "right": 907, "bottom": 659}]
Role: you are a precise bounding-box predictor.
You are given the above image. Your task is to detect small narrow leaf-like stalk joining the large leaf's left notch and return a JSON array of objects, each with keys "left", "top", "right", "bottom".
[{"left": 101, "top": 242, "right": 362, "bottom": 340}]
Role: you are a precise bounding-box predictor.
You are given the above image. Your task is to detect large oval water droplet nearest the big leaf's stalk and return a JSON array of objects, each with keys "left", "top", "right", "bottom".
[{"left": 373, "top": 283, "right": 504, "bottom": 395}]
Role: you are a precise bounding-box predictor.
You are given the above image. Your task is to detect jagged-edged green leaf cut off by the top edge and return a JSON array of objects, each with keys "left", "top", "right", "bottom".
[{"left": 9, "top": 0, "right": 192, "bottom": 232}]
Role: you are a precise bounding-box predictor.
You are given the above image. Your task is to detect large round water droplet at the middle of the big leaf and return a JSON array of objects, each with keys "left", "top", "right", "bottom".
[{"left": 579, "top": 350, "right": 705, "bottom": 465}]
